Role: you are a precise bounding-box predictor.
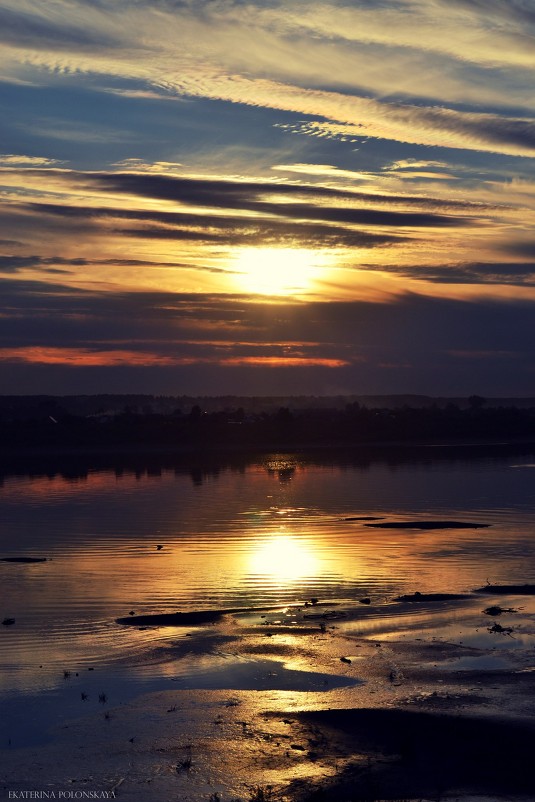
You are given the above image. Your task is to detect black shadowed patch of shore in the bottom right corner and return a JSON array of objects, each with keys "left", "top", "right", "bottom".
[{"left": 296, "top": 708, "right": 535, "bottom": 802}]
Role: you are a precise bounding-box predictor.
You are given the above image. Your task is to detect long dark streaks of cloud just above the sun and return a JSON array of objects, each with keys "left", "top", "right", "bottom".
[{"left": 10, "top": 173, "right": 468, "bottom": 253}]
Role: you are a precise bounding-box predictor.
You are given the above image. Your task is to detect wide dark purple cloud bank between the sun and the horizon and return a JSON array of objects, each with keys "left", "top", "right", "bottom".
[{"left": 0, "top": 279, "right": 535, "bottom": 396}]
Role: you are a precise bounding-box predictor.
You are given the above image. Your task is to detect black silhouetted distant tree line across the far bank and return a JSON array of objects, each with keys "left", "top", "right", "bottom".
[{"left": 0, "top": 396, "right": 535, "bottom": 448}]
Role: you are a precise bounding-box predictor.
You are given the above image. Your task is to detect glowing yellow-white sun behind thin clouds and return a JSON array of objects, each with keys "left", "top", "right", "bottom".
[{"left": 234, "top": 247, "right": 327, "bottom": 295}]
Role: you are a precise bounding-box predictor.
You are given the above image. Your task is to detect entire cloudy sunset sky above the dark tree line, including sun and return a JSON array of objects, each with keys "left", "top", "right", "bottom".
[{"left": 0, "top": 0, "right": 535, "bottom": 397}]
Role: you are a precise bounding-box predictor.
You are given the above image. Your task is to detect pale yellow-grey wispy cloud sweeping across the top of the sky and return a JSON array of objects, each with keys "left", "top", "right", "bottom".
[{"left": 4, "top": 0, "right": 535, "bottom": 156}]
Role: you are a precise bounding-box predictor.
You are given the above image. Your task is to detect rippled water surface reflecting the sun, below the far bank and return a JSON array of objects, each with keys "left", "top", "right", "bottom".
[{"left": 0, "top": 448, "right": 535, "bottom": 698}]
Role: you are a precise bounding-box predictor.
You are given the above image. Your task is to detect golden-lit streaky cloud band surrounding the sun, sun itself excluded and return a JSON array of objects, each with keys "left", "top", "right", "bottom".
[{"left": 0, "top": 161, "right": 532, "bottom": 297}]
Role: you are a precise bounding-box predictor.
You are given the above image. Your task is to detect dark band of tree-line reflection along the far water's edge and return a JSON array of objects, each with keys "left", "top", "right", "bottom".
[{"left": 0, "top": 438, "right": 535, "bottom": 481}]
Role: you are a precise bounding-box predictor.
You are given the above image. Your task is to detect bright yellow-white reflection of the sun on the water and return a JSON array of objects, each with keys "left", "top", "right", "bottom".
[{"left": 251, "top": 535, "right": 321, "bottom": 582}]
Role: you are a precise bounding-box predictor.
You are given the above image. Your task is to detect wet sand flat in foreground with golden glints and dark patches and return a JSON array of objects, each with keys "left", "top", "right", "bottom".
[{"left": 0, "top": 586, "right": 535, "bottom": 802}]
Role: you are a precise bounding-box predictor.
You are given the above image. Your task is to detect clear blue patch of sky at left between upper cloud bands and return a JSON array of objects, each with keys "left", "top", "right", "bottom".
[{"left": 0, "top": 84, "right": 310, "bottom": 169}]
